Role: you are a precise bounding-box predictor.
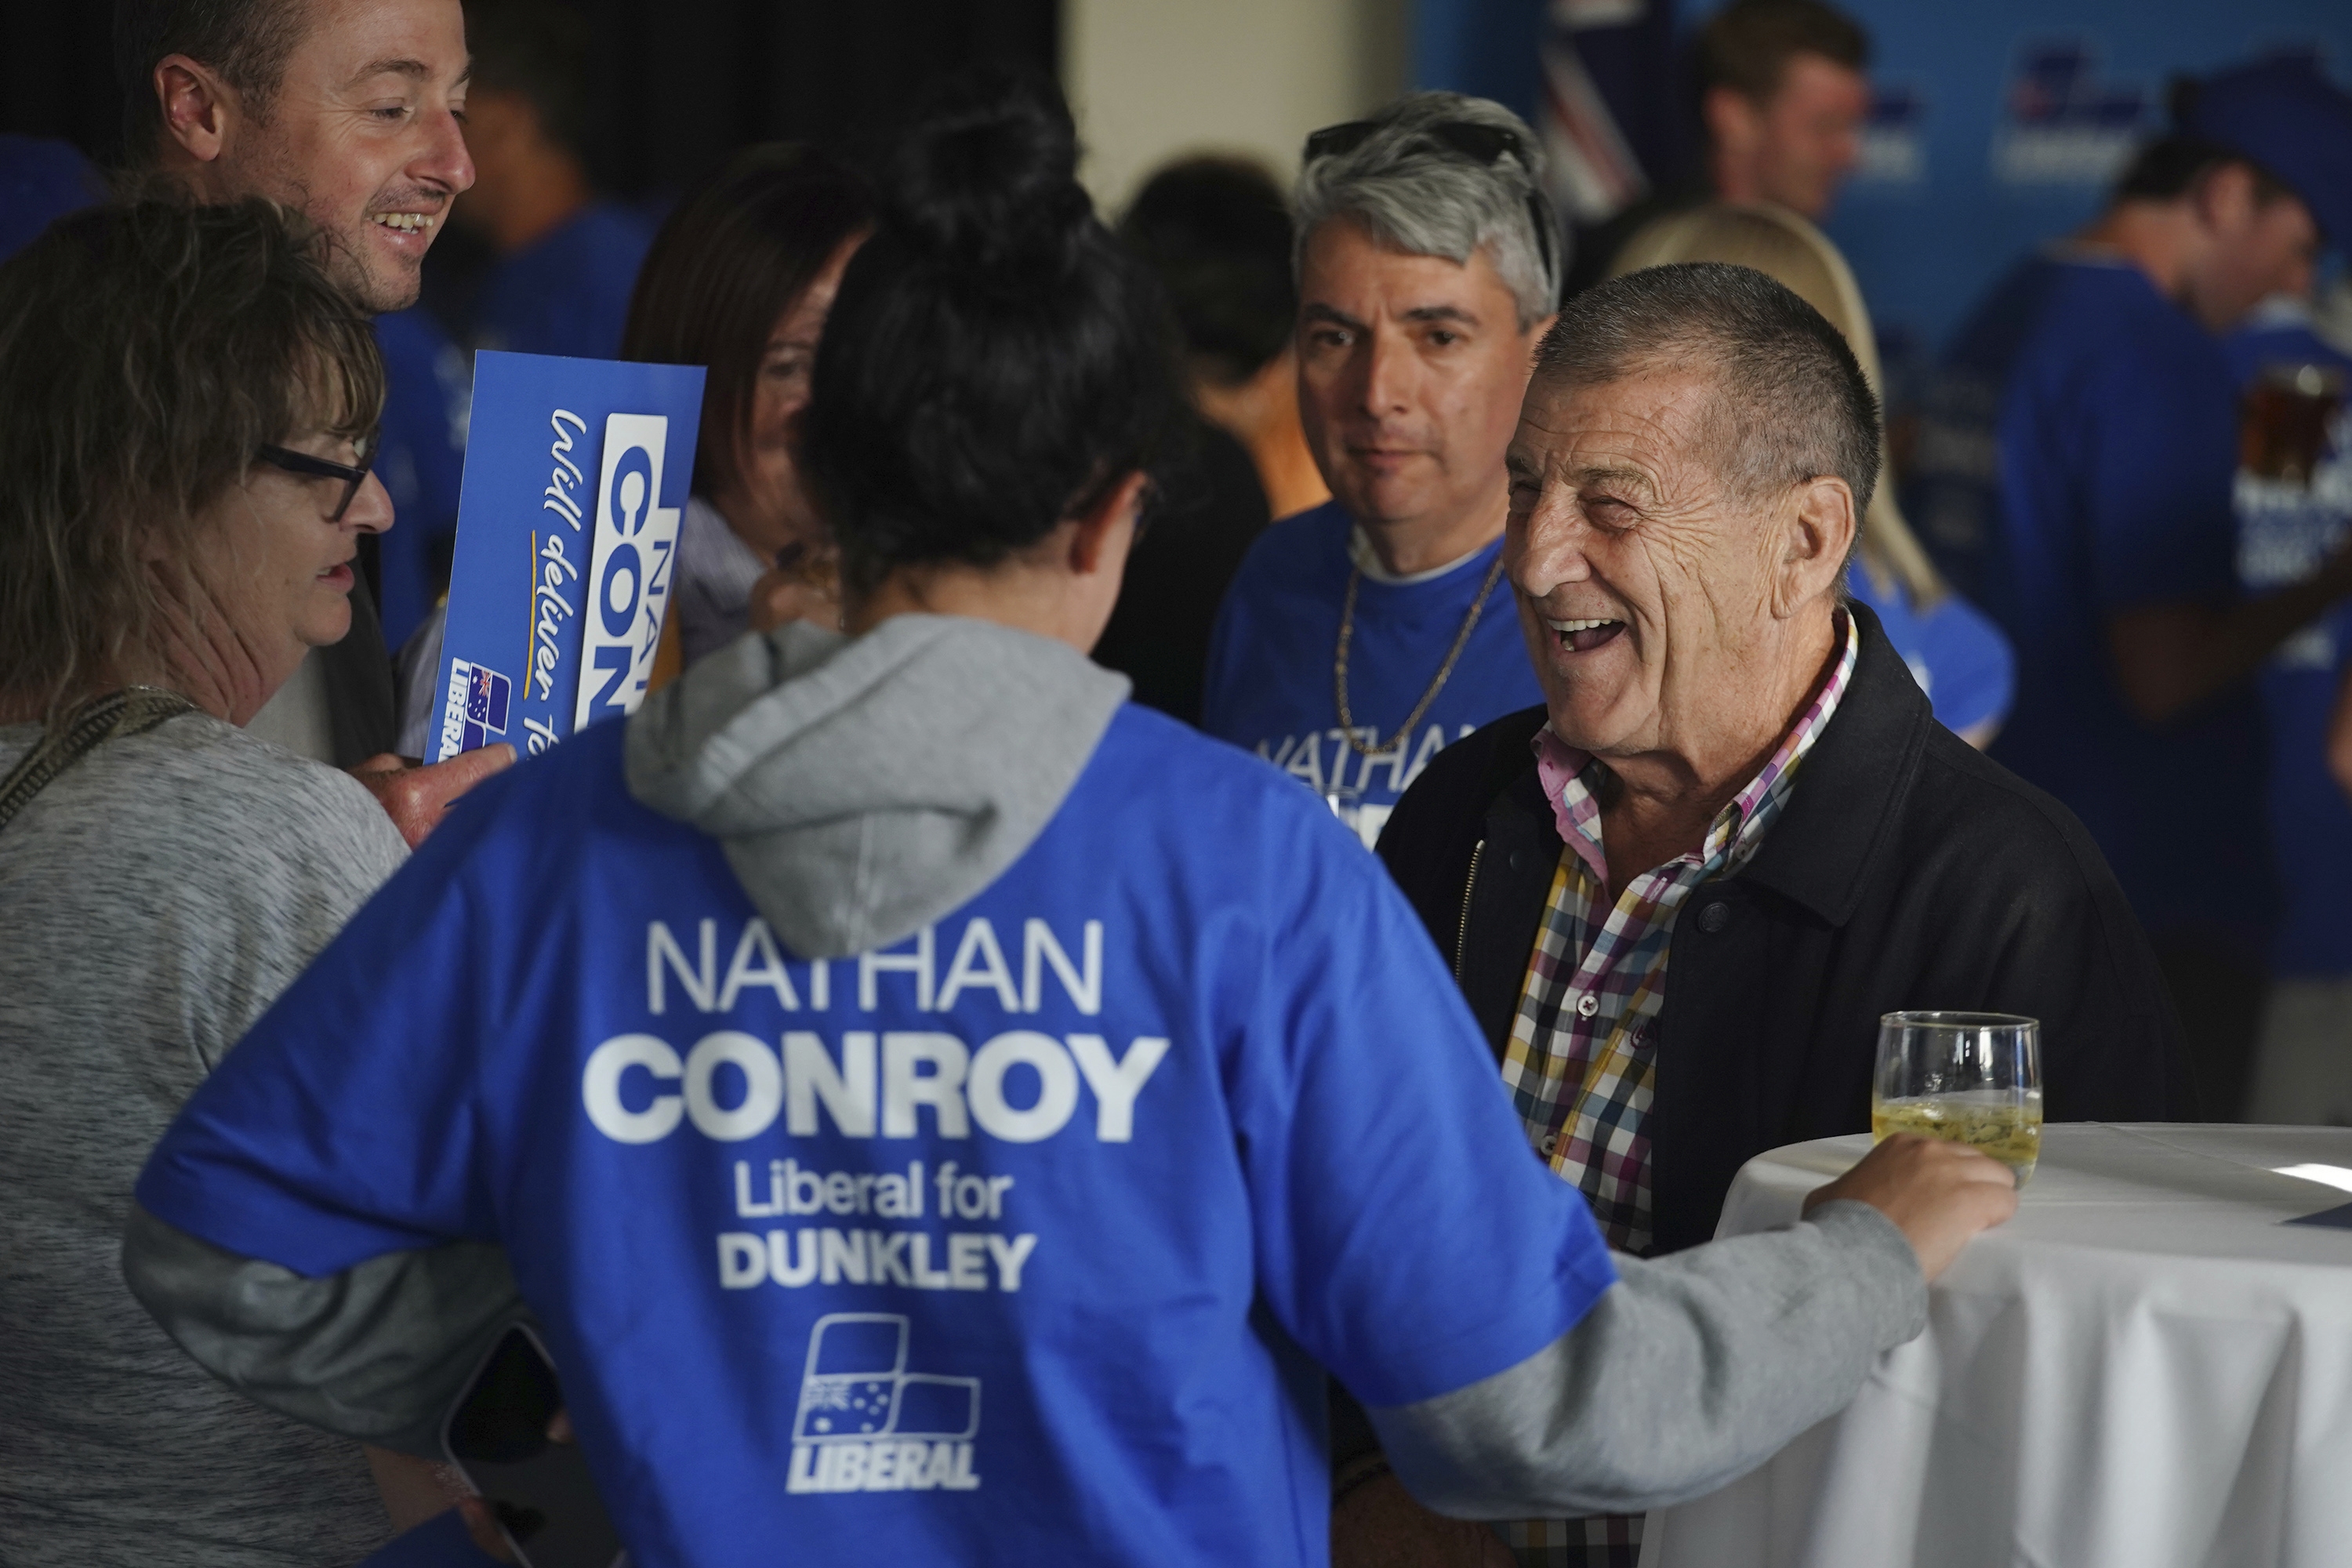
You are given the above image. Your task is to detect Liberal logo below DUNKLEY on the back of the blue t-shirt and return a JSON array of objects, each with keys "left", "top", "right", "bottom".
[{"left": 790, "top": 1312, "right": 981, "bottom": 1493}]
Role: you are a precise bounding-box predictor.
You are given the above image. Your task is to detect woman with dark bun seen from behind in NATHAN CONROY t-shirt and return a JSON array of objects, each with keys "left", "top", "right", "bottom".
[{"left": 125, "top": 73, "right": 2013, "bottom": 1568}]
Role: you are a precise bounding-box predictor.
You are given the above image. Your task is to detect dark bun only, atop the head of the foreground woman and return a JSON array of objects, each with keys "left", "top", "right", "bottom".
[{"left": 884, "top": 66, "right": 1094, "bottom": 268}]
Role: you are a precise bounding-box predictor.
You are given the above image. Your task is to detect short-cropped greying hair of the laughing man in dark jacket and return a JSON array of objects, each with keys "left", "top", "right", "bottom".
[{"left": 1536, "top": 261, "right": 1879, "bottom": 526}]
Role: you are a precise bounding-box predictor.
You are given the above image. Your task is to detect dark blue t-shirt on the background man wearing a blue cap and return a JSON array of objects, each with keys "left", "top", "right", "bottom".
[{"left": 1905, "top": 254, "right": 2272, "bottom": 952}]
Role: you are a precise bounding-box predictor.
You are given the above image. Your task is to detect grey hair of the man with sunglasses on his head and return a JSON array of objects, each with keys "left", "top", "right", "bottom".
[{"left": 1291, "top": 92, "right": 1562, "bottom": 332}]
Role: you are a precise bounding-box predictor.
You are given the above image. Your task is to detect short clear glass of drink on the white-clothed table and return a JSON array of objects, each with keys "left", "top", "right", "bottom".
[{"left": 1870, "top": 1013, "right": 2042, "bottom": 1187}]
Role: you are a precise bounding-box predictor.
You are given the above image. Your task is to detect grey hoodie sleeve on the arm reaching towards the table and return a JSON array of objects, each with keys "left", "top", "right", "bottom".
[{"left": 1371, "top": 1201, "right": 1926, "bottom": 1519}]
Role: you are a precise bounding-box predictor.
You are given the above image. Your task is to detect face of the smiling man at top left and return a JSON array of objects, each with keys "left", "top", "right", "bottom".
[{"left": 219, "top": 0, "right": 473, "bottom": 310}]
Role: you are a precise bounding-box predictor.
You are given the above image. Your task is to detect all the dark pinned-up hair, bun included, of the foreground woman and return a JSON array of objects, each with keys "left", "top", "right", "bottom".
[{"left": 800, "top": 66, "right": 1183, "bottom": 593}]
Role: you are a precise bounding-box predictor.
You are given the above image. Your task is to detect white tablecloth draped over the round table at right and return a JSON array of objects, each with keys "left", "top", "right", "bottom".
[{"left": 1642, "top": 1123, "right": 2352, "bottom": 1568}]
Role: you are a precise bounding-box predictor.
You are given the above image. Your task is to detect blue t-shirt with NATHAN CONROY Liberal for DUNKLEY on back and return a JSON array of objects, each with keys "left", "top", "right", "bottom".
[{"left": 139, "top": 706, "right": 1613, "bottom": 1568}]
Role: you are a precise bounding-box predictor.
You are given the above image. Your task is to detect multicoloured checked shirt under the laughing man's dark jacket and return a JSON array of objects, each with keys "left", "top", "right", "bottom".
[{"left": 1498, "top": 616, "right": 1860, "bottom": 1568}]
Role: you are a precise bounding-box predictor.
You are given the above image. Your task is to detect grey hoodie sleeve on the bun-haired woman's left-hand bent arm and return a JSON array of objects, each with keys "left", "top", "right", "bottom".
[{"left": 122, "top": 1203, "right": 527, "bottom": 1460}]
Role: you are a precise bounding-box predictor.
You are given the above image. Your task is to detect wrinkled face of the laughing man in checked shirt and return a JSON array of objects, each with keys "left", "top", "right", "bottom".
[{"left": 1503, "top": 369, "right": 1780, "bottom": 757}]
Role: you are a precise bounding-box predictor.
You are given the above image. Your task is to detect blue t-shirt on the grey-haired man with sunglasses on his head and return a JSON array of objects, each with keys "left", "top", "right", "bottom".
[{"left": 1202, "top": 501, "right": 1543, "bottom": 844}]
